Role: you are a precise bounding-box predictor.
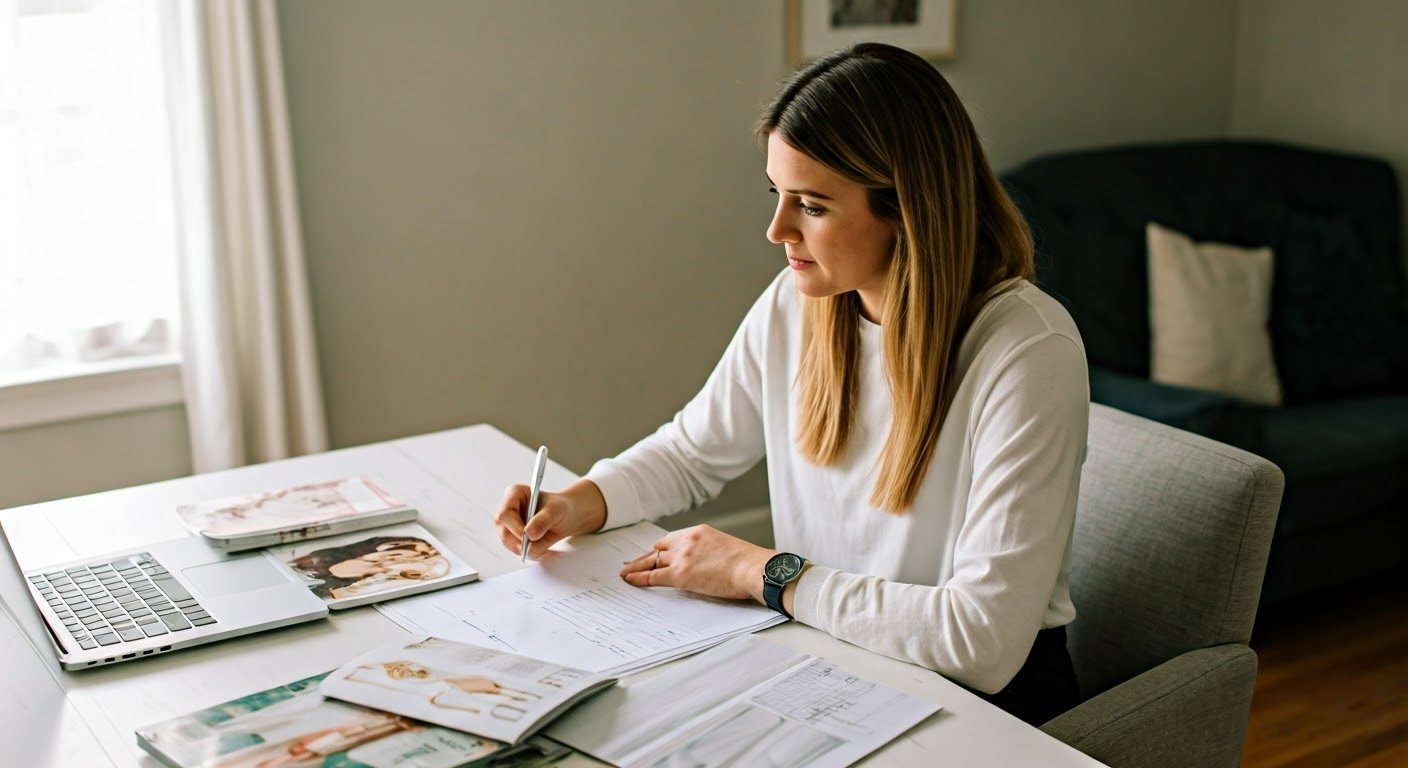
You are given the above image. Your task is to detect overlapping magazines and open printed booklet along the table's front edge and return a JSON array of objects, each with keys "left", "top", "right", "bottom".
[{"left": 137, "top": 636, "right": 942, "bottom": 768}]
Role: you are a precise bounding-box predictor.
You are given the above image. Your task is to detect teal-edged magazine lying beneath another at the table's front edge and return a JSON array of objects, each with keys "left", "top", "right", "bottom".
[{"left": 137, "top": 672, "right": 570, "bottom": 768}]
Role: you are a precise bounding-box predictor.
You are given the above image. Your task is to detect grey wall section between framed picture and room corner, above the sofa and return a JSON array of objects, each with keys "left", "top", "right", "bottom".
[{"left": 939, "top": 0, "right": 1236, "bottom": 169}]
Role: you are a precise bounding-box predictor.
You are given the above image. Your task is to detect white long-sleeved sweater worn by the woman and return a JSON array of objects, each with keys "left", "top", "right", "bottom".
[{"left": 587, "top": 271, "right": 1090, "bottom": 693}]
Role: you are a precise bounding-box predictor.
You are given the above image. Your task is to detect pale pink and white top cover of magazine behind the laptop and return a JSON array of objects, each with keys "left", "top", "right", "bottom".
[{"left": 176, "top": 478, "right": 407, "bottom": 540}]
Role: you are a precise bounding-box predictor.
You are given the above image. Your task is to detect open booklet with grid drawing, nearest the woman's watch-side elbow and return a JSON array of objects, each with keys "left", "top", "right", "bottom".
[{"left": 543, "top": 637, "right": 941, "bottom": 768}]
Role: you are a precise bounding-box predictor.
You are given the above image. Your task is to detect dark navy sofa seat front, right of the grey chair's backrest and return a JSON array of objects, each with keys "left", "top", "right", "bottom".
[{"left": 1259, "top": 396, "right": 1408, "bottom": 535}]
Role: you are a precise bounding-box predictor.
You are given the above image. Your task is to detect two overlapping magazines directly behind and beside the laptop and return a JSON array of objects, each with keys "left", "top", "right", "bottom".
[{"left": 176, "top": 476, "right": 479, "bottom": 609}]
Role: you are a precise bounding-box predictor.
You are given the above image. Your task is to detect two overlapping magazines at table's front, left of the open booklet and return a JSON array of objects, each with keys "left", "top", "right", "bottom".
[{"left": 137, "top": 637, "right": 615, "bottom": 768}]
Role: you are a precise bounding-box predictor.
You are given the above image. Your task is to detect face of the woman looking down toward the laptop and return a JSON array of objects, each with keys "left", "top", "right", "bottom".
[{"left": 767, "top": 131, "right": 895, "bottom": 323}]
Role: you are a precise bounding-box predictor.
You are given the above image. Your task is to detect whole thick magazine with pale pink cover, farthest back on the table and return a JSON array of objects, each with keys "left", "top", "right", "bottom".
[{"left": 176, "top": 478, "right": 415, "bottom": 552}]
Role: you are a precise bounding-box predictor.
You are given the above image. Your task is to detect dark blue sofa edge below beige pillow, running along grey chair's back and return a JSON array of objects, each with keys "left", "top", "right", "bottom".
[{"left": 1090, "top": 365, "right": 1262, "bottom": 454}]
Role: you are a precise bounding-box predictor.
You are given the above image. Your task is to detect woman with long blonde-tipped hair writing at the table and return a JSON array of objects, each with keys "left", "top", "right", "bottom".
[{"left": 496, "top": 44, "right": 1088, "bottom": 723}]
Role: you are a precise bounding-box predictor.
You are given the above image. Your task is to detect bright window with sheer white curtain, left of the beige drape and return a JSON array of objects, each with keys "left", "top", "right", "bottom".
[{"left": 0, "top": 0, "right": 180, "bottom": 386}]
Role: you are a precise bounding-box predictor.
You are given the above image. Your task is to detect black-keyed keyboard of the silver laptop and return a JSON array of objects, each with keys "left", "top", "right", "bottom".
[{"left": 28, "top": 552, "right": 215, "bottom": 651}]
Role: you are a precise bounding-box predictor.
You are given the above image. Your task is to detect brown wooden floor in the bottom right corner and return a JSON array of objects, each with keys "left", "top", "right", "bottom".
[{"left": 1242, "top": 574, "right": 1408, "bottom": 768}]
